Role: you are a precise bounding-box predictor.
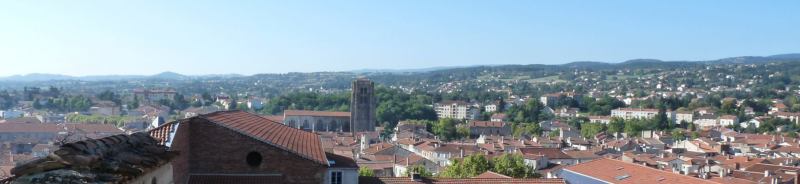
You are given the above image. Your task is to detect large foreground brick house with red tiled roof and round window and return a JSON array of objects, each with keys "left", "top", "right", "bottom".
[{"left": 150, "top": 111, "right": 358, "bottom": 183}]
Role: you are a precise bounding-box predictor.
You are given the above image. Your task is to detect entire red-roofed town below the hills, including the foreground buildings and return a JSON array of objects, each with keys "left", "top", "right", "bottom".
[{"left": 0, "top": 61, "right": 800, "bottom": 184}]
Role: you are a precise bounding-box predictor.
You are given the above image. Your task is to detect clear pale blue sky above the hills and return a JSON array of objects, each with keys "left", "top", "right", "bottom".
[{"left": 0, "top": 0, "right": 800, "bottom": 76}]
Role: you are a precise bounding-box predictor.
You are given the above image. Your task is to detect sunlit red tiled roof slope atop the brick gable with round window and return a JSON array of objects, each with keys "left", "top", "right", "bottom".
[{"left": 195, "top": 111, "right": 328, "bottom": 166}]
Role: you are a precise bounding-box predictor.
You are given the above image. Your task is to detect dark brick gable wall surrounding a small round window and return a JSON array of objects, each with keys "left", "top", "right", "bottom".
[{"left": 172, "top": 119, "right": 327, "bottom": 183}]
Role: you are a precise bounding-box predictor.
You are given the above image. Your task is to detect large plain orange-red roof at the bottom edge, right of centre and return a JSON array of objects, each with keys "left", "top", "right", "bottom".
[{"left": 562, "top": 158, "right": 716, "bottom": 184}]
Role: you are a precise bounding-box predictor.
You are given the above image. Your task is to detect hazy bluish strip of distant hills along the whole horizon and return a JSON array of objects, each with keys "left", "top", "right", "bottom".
[{"left": 0, "top": 53, "right": 800, "bottom": 82}]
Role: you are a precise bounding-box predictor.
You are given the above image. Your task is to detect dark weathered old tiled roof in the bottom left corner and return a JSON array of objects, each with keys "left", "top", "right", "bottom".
[{"left": 0, "top": 133, "right": 177, "bottom": 183}]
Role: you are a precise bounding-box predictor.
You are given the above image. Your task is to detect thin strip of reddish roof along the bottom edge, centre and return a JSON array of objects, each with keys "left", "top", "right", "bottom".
[{"left": 358, "top": 177, "right": 565, "bottom": 184}]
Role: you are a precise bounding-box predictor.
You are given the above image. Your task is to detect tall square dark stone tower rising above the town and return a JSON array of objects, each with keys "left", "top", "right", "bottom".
[{"left": 350, "top": 78, "right": 377, "bottom": 135}]
